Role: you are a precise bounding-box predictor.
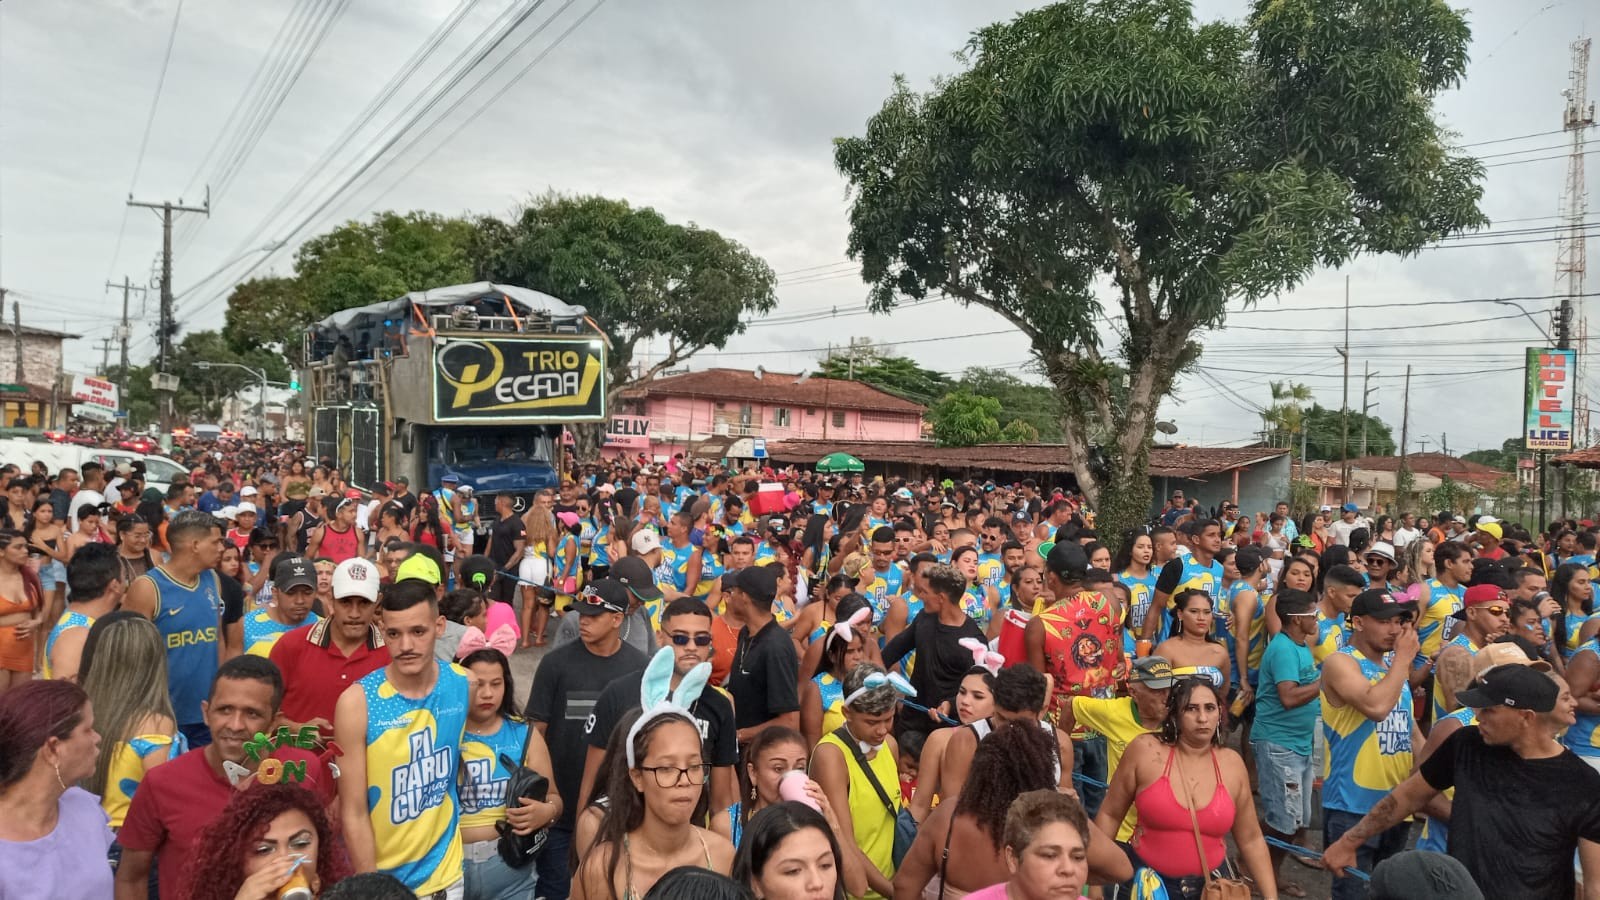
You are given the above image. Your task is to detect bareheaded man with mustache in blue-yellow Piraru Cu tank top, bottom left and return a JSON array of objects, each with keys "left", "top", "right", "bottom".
[{"left": 333, "top": 578, "right": 472, "bottom": 900}]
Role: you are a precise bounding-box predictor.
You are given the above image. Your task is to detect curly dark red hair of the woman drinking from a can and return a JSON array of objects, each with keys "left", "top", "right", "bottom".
[{"left": 189, "top": 783, "right": 350, "bottom": 900}]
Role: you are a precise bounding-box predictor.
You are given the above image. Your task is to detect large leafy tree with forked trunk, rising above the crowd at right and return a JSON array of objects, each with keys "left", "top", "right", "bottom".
[{"left": 835, "top": 0, "right": 1486, "bottom": 533}]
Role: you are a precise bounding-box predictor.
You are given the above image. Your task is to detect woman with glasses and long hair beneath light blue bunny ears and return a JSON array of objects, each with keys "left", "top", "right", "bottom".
[{"left": 571, "top": 701, "right": 733, "bottom": 900}]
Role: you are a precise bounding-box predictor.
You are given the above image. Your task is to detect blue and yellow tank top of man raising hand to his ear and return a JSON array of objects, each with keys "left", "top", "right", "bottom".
[{"left": 1322, "top": 647, "right": 1414, "bottom": 815}]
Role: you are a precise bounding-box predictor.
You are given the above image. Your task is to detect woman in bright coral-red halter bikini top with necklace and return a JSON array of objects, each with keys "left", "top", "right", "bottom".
[{"left": 1096, "top": 677, "right": 1278, "bottom": 900}]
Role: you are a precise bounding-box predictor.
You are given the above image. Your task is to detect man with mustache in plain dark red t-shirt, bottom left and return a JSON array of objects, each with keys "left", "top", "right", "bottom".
[{"left": 117, "top": 655, "right": 321, "bottom": 900}]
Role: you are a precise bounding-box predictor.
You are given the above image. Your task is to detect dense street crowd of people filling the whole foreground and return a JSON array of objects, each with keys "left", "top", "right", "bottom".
[{"left": 0, "top": 445, "right": 1600, "bottom": 900}]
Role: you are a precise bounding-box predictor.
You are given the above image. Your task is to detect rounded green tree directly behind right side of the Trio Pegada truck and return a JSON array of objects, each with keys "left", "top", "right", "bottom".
[{"left": 483, "top": 194, "right": 778, "bottom": 450}]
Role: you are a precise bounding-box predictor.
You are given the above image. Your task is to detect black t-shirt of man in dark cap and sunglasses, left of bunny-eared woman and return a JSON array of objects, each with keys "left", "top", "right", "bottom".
[{"left": 526, "top": 641, "right": 650, "bottom": 828}]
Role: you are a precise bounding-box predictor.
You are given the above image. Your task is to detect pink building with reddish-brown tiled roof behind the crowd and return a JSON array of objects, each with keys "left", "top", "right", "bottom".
[{"left": 606, "top": 368, "right": 923, "bottom": 460}]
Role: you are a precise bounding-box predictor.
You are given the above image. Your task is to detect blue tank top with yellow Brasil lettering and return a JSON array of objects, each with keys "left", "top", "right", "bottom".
[{"left": 144, "top": 565, "right": 222, "bottom": 725}]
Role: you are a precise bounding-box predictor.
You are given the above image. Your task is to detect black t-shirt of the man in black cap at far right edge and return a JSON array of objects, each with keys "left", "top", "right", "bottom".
[{"left": 1421, "top": 725, "right": 1600, "bottom": 900}]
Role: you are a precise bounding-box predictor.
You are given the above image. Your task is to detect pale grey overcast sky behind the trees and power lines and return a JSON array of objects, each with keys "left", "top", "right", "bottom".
[{"left": 0, "top": 0, "right": 1600, "bottom": 453}]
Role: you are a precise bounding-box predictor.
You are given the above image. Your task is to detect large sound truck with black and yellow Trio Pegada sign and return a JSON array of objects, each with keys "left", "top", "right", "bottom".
[{"left": 301, "top": 282, "right": 608, "bottom": 517}]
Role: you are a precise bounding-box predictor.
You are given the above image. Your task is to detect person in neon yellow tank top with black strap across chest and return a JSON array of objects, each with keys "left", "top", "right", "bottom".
[{"left": 811, "top": 663, "right": 901, "bottom": 900}]
